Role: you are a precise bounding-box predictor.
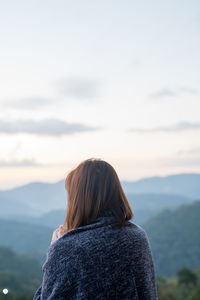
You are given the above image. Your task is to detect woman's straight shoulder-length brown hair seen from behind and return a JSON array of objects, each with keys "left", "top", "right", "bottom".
[{"left": 64, "top": 158, "right": 134, "bottom": 230}]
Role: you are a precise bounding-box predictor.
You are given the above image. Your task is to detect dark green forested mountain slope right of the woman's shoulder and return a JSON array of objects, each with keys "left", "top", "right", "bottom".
[{"left": 143, "top": 201, "right": 200, "bottom": 276}]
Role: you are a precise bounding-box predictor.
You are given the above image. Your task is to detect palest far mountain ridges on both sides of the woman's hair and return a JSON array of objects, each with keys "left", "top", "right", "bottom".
[{"left": 0, "top": 174, "right": 200, "bottom": 219}]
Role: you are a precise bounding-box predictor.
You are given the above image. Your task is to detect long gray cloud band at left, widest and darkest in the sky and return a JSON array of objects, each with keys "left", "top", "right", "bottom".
[{"left": 0, "top": 119, "right": 98, "bottom": 136}]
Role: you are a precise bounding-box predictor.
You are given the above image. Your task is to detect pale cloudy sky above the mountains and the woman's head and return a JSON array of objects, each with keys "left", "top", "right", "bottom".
[{"left": 0, "top": 0, "right": 200, "bottom": 189}]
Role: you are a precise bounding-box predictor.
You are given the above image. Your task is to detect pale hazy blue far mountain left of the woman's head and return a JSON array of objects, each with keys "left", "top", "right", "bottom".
[{"left": 0, "top": 181, "right": 67, "bottom": 216}]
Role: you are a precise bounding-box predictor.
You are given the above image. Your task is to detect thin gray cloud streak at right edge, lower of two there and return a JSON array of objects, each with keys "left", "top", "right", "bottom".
[{"left": 128, "top": 122, "right": 200, "bottom": 133}]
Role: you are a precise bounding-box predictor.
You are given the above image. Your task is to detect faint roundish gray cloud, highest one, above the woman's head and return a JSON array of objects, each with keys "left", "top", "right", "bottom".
[{"left": 57, "top": 77, "right": 101, "bottom": 99}]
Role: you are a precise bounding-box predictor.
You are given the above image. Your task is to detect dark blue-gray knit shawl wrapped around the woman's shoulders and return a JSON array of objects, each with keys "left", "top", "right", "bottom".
[{"left": 33, "top": 211, "right": 158, "bottom": 300}]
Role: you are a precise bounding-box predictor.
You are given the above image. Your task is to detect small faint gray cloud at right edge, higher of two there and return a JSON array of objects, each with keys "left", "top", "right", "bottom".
[{"left": 150, "top": 87, "right": 198, "bottom": 99}]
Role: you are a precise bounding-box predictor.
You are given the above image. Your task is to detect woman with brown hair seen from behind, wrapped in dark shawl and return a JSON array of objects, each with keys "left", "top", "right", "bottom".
[{"left": 34, "top": 159, "right": 157, "bottom": 300}]
